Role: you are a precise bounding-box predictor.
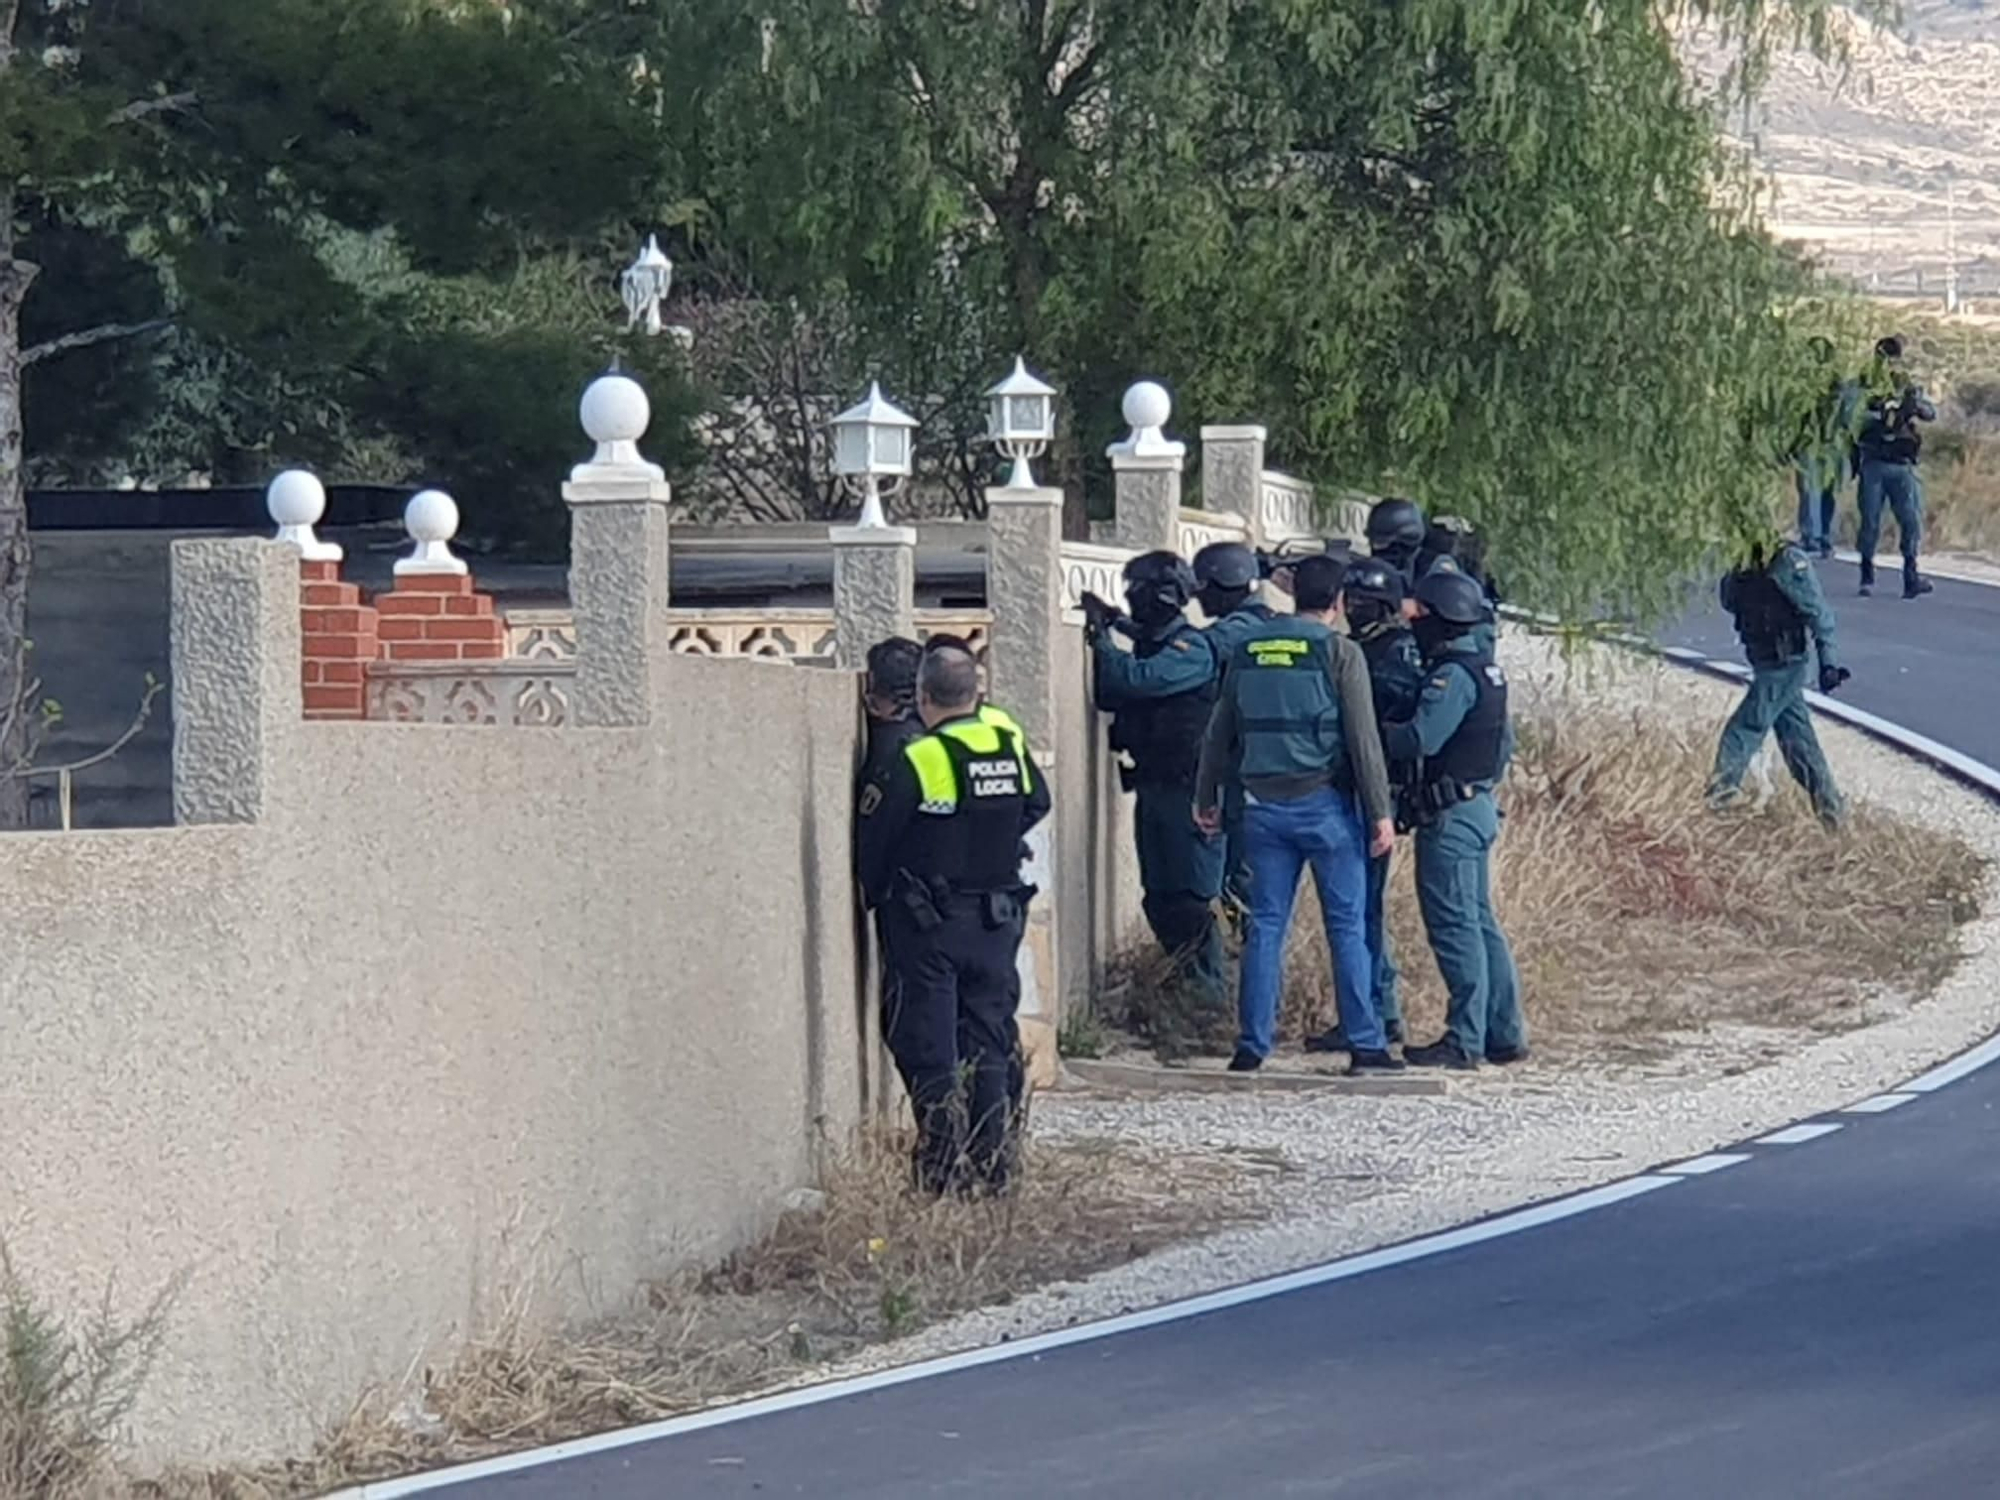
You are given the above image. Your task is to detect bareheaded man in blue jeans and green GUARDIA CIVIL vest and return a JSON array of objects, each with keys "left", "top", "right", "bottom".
[{"left": 1194, "top": 554, "right": 1402, "bottom": 1074}]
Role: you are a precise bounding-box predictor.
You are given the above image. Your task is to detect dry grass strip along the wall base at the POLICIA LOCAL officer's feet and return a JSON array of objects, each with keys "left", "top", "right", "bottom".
[{"left": 124, "top": 1132, "right": 1250, "bottom": 1500}]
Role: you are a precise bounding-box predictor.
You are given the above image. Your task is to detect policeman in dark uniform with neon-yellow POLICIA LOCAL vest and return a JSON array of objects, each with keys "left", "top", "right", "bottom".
[{"left": 860, "top": 648, "right": 1050, "bottom": 1192}]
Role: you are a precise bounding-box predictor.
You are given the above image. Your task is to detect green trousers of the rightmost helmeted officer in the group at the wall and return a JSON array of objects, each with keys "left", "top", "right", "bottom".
[{"left": 1416, "top": 792, "right": 1528, "bottom": 1058}]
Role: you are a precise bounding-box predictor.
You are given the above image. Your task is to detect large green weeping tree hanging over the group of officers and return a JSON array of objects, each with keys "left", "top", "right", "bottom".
[{"left": 620, "top": 0, "right": 1856, "bottom": 614}]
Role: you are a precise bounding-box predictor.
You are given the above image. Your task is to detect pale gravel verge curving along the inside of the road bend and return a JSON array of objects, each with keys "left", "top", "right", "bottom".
[{"left": 820, "top": 632, "right": 2000, "bottom": 1372}]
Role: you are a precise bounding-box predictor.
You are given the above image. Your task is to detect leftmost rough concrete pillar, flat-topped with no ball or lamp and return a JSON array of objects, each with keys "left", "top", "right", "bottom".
[{"left": 168, "top": 538, "right": 304, "bottom": 824}]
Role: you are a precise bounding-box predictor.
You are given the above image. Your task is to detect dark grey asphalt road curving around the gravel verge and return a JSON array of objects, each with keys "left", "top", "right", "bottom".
[{"left": 410, "top": 564, "right": 2000, "bottom": 1500}]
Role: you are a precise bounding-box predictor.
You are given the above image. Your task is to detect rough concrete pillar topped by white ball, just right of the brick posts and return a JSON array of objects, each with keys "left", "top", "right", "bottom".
[{"left": 562, "top": 374, "right": 674, "bottom": 728}]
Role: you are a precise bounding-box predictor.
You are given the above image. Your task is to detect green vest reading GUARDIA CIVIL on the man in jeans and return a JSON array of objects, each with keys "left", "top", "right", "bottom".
[{"left": 1230, "top": 616, "right": 1352, "bottom": 786}]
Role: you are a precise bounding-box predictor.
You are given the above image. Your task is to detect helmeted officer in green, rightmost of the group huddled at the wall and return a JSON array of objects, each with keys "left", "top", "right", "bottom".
[{"left": 1384, "top": 568, "right": 1528, "bottom": 1068}]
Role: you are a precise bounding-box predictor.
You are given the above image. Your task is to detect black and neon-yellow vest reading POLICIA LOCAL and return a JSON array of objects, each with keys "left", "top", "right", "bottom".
[{"left": 902, "top": 708, "right": 1034, "bottom": 890}]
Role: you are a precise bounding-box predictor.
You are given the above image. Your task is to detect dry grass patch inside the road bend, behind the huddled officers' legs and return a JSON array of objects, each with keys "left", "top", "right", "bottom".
[{"left": 1106, "top": 708, "right": 1984, "bottom": 1058}]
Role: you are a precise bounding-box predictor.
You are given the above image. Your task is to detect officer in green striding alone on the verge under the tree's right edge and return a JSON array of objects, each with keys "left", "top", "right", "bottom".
[{"left": 1708, "top": 534, "right": 1850, "bottom": 828}]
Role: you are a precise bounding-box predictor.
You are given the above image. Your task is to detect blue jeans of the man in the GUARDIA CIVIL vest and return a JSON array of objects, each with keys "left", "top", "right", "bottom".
[{"left": 1236, "top": 788, "right": 1386, "bottom": 1058}]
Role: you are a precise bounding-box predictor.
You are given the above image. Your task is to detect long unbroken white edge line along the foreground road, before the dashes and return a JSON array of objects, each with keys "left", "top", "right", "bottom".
[{"left": 326, "top": 1174, "right": 1680, "bottom": 1500}]
